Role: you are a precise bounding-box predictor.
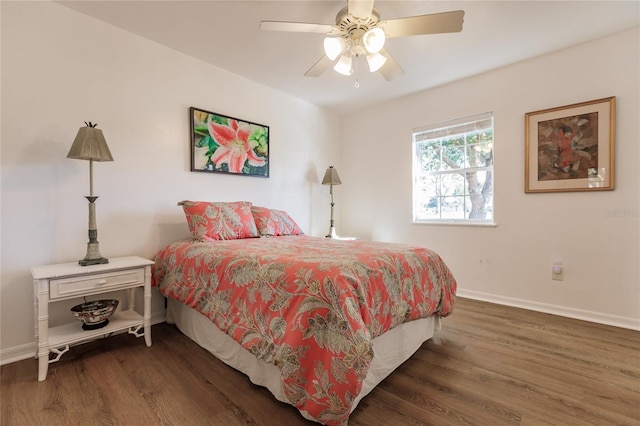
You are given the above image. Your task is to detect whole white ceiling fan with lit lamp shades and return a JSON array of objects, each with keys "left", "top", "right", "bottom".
[{"left": 260, "top": 0, "right": 464, "bottom": 81}]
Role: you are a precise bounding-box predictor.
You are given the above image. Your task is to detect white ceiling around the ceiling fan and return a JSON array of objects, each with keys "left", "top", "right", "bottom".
[{"left": 57, "top": 0, "right": 640, "bottom": 112}]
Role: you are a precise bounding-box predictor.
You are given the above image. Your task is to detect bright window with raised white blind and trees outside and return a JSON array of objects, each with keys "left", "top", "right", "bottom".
[{"left": 413, "top": 113, "right": 493, "bottom": 224}]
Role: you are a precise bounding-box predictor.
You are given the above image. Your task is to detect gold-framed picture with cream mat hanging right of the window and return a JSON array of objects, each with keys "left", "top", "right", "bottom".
[{"left": 524, "top": 96, "right": 616, "bottom": 193}]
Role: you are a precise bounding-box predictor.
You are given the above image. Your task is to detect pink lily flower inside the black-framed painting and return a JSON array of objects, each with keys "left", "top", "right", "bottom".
[{"left": 209, "top": 120, "right": 266, "bottom": 173}]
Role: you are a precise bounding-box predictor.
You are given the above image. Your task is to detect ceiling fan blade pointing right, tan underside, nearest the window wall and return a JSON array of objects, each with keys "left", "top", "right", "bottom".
[{"left": 379, "top": 10, "right": 464, "bottom": 38}]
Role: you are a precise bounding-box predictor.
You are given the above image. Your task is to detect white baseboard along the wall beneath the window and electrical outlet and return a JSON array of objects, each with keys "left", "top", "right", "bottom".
[{"left": 457, "top": 288, "right": 640, "bottom": 331}]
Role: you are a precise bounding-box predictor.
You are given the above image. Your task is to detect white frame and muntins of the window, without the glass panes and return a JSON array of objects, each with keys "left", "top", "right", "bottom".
[{"left": 412, "top": 112, "right": 495, "bottom": 226}]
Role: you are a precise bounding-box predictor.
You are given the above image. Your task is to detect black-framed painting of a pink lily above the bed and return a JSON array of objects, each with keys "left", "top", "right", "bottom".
[{"left": 189, "top": 107, "right": 269, "bottom": 177}]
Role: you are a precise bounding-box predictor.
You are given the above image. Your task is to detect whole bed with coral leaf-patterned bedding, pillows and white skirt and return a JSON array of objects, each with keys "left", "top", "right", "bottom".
[{"left": 152, "top": 202, "right": 456, "bottom": 425}]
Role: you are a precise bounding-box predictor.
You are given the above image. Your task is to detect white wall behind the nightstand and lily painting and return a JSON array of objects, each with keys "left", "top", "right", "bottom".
[{"left": 0, "top": 2, "right": 339, "bottom": 362}]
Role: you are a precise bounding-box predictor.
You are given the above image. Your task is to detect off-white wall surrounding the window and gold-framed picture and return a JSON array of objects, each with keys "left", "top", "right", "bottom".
[{"left": 336, "top": 29, "right": 640, "bottom": 329}]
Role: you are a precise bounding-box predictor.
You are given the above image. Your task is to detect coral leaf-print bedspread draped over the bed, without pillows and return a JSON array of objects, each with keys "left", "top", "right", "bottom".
[{"left": 152, "top": 235, "right": 456, "bottom": 425}]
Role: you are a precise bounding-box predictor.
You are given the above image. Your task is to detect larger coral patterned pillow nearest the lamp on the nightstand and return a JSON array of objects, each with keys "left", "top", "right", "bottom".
[{"left": 180, "top": 201, "right": 259, "bottom": 241}]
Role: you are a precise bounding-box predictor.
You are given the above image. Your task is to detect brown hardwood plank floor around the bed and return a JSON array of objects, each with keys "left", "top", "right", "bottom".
[{"left": 0, "top": 299, "right": 640, "bottom": 426}]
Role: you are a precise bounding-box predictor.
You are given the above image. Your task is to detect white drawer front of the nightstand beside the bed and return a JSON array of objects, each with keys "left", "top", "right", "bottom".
[{"left": 49, "top": 268, "right": 144, "bottom": 299}]
